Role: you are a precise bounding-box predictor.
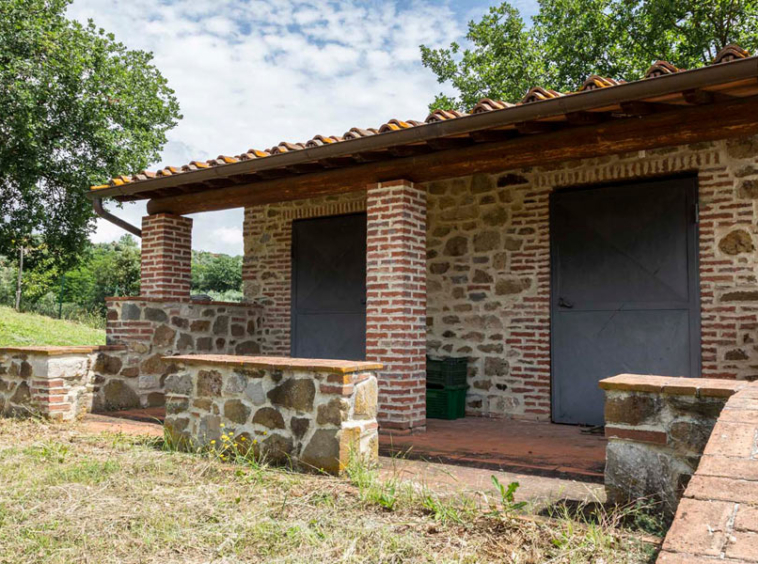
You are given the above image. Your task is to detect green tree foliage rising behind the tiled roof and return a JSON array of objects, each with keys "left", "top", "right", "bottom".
[{"left": 421, "top": 0, "right": 758, "bottom": 110}]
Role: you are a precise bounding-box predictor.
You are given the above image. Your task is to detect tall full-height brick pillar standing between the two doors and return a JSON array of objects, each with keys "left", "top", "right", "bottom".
[{"left": 366, "top": 180, "right": 426, "bottom": 432}]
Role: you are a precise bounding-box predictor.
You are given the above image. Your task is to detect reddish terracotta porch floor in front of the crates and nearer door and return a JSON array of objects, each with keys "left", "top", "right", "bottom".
[{"left": 379, "top": 417, "right": 606, "bottom": 482}]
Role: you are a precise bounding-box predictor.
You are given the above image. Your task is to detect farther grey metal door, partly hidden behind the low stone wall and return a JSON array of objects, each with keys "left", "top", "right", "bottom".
[{"left": 292, "top": 214, "right": 366, "bottom": 360}]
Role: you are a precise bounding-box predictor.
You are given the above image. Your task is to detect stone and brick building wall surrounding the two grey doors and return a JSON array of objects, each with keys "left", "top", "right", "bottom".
[{"left": 243, "top": 137, "right": 758, "bottom": 420}]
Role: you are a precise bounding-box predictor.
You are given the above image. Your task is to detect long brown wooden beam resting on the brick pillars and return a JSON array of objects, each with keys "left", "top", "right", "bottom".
[{"left": 148, "top": 96, "right": 758, "bottom": 215}]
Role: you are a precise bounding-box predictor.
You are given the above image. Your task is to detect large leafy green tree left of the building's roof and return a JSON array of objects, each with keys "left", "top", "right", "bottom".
[{"left": 0, "top": 0, "right": 181, "bottom": 265}]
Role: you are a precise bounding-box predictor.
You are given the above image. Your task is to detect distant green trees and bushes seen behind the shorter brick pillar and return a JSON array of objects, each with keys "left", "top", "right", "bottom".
[{"left": 0, "top": 235, "right": 242, "bottom": 327}]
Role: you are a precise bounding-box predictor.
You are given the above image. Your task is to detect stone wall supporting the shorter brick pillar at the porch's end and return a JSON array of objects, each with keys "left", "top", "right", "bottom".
[{"left": 104, "top": 298, "right": 261, "bottom": 410}]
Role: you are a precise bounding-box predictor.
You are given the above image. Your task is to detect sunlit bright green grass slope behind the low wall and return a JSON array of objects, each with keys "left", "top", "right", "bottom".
[{"left": 0, "top": 306, "right": 105, "bottom": 346}]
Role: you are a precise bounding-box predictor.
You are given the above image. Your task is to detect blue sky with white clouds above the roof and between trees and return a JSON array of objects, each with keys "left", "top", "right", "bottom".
[{"left": 69, "top": 0, "right": 536, "bottom": 254}]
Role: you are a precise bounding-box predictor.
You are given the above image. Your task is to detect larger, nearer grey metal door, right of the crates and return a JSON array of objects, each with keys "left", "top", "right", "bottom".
[{"left": 551, "top": 177, "right": 700, "bottom": 425}]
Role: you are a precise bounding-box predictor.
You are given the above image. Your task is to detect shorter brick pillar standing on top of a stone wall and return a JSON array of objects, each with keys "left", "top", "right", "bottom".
[{"left": 140, "top": 213, "right": 192, "bottom": 299}]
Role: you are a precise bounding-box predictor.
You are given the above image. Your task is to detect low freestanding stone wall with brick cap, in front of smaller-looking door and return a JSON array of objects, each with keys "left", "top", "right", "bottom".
[{"left": 166, "top": 355, "right": 381, "bottom": 474}]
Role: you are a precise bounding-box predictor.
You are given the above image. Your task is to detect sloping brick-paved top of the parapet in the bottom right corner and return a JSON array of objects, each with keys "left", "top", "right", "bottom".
[{"left": 657, "top": 384, "right": 758, "bottom": 564}]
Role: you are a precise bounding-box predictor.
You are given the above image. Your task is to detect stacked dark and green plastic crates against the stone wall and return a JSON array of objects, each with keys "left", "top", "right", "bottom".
[{"left": 426, "top": 357, "right": 468, "bottom": 419}]
